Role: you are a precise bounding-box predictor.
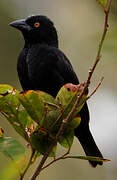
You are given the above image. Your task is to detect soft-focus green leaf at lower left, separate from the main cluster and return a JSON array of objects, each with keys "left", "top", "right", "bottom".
[{"left": 0, "top": 137, "right": 25, "bottom": 160}]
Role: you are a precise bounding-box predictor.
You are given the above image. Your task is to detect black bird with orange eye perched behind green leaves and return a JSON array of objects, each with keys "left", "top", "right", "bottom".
[{"left": 10, "top": 15, "right": 103, "bottom": 167}]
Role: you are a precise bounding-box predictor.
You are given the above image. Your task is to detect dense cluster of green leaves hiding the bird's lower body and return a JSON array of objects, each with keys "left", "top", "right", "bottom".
[{"left": 0, "top": 85, "right": 87, "bottom": 156}]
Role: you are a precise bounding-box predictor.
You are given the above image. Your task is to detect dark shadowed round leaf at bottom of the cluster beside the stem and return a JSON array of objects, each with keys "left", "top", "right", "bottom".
[{"left": 31, "top": 129, "right": 56, "bottom": 157}]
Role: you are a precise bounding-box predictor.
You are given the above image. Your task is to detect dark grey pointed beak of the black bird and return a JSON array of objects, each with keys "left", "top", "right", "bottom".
[{"left": 9, "top": 19, "right": 30, "bottom": 31}]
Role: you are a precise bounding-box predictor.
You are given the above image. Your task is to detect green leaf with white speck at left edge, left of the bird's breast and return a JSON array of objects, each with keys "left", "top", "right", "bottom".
[{"left": 0, "top": 85, "right": 29, "bottom": 140}]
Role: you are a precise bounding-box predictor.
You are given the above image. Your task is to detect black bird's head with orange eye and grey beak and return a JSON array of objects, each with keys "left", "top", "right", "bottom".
[{"left": 10, "top": 15, "right": 58, "bottom": 46}]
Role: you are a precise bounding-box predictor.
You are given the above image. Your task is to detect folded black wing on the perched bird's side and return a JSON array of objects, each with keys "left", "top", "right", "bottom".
[{"left": 27, "top": 48, "right": 79, "bottom": 96}]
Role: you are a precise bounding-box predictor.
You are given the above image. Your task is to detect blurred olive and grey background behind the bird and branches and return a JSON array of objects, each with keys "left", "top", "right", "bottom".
[{"left": 0, "top": 0, "right": 117, "bottom": 180}]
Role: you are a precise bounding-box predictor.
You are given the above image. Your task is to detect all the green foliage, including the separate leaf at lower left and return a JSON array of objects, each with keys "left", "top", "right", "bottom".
[{"left": 0, "top": 84, "right": 109, "bottom": 177}]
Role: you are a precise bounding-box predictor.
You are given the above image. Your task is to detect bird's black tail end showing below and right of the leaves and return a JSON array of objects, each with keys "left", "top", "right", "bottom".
[{"left": 75, "top": 103, "right": 103, "bottom": 167}]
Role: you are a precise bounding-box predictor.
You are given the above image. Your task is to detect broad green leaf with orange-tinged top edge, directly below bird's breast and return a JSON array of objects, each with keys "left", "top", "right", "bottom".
[{"left": 19, "top": 90, "right": 61, "bottom": 130}]
